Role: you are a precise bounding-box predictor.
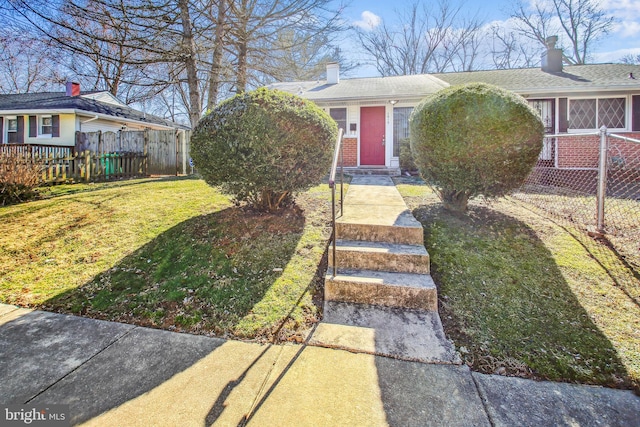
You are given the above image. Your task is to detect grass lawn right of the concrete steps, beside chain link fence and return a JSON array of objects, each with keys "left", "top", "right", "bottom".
[{"left": 398, "top": 178, "right": 640, "bottom": 390}]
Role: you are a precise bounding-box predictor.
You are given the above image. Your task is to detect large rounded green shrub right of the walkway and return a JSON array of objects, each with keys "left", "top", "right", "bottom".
[{"left": 409, "top": 83, "right": 544, "bottom": 211}]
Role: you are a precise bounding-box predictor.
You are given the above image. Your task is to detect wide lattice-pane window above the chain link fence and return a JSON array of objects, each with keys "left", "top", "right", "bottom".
[{"left": 569, "top": 98, "right": 627, "bottom": 129}]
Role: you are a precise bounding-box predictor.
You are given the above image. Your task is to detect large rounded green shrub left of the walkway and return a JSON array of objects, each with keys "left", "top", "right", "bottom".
[{"left": 191, "top": 88, "right": 338, "bottom": 211}]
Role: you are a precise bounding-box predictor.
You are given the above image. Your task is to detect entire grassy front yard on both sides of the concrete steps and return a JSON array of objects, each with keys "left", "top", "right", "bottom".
[{"left": 0, "top": 173, "right": 640, "bottom": 390}]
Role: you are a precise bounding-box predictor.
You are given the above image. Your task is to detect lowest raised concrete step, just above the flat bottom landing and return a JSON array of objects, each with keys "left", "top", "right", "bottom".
[{"left": 324, "top": 268, "right": 438, "bottom": 312}]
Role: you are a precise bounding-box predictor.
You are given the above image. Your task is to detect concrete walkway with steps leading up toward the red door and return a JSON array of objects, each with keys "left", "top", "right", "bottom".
[{"left": 318, "top": 175, "right": 461, "bottom": 364}]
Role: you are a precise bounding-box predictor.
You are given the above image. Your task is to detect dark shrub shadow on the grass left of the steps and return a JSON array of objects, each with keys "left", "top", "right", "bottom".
[{"left": 44, "top": 207, "right": 312, "bottom": 338}]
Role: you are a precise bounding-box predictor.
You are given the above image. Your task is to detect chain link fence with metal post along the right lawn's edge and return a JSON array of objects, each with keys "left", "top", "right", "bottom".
[{"left": 513, "top": 128, "right": 640, "bottom": 280}]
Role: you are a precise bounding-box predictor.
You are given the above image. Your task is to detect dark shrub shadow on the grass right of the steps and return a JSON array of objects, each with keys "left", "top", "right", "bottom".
[{"left": 413, "top": 204, "right": 637, "bottom": 387}]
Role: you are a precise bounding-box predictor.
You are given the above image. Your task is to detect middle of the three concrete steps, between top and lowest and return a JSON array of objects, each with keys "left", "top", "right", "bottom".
[{"left": 329, "top": 240, "right": 429, "bottom": 274}]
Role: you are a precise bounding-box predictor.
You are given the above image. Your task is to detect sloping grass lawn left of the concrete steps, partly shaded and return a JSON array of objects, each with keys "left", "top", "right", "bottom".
[{"left": 0, "top": 178, "right": 338, "bottom": 340}]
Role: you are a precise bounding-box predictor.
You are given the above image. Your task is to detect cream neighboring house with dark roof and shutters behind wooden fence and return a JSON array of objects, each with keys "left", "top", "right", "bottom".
[{"left": 0, "top": 83, "right": 189, "bottom": 147}]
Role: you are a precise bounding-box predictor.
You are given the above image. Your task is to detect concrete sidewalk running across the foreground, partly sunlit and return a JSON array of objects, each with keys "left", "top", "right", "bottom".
[{"left": 0, "top": 304, "right": 640, "bottom": 426}]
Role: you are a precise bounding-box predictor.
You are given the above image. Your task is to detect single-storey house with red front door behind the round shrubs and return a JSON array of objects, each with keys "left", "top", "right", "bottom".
[{"left": 270, "top": 48, "right": 640, "bottom": 173}]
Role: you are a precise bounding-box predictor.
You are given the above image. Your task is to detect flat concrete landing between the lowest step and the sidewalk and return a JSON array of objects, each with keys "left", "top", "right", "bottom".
[{"left": 309, "top": 301, "right": 461, "bottom": 364}]
